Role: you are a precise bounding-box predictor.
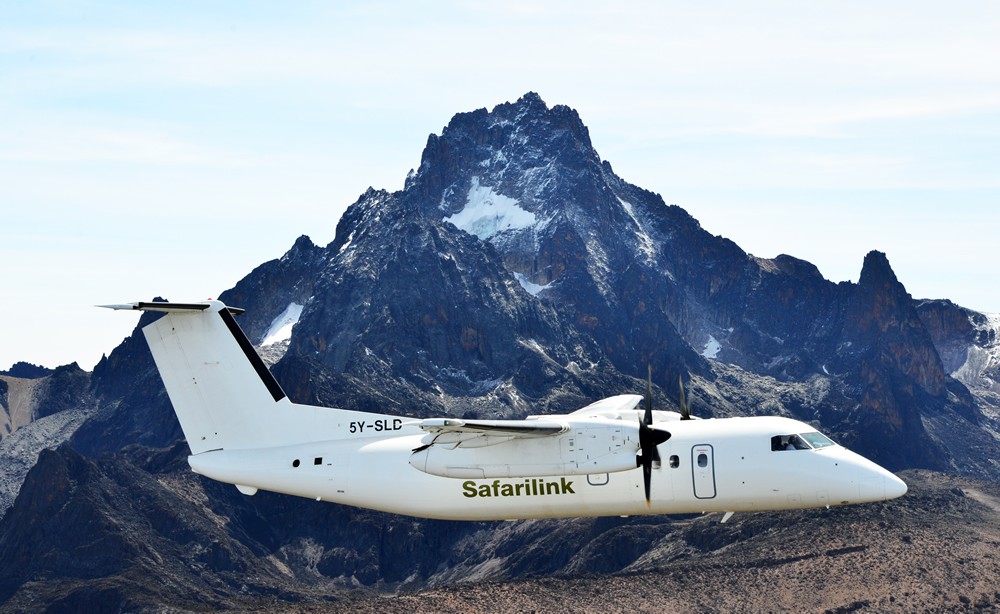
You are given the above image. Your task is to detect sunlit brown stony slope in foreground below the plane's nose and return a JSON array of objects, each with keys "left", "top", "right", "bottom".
[{"left": 341, "top": 471, "right": 1000, "bottom": 612}]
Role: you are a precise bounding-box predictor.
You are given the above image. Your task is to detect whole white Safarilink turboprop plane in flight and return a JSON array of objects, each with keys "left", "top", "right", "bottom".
[{"left": 102, "top": 300, "right": 906, "bottom": 522}]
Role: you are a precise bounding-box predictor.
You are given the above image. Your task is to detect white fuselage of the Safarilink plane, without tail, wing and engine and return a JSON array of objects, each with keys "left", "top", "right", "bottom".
[{"left": 189, "top": 410, "right": 906, "bottom": 520}]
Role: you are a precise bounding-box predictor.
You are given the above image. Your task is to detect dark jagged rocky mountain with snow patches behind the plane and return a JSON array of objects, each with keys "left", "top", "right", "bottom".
[{"left": 0, "top": 93, "right": 1000, "bottom": 609}]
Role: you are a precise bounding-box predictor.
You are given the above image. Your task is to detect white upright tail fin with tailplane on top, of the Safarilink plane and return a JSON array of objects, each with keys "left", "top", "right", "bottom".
[{"left": 102, "top": 301, "right": 290, "bottom": 454}]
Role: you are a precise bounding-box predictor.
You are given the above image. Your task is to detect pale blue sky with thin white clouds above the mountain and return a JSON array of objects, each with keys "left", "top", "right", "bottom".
[{"left": 0, "top": 0, "right": 1000, "bottom": 369}]
